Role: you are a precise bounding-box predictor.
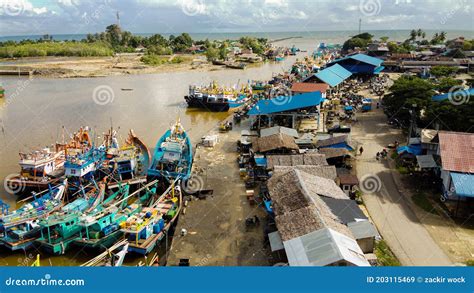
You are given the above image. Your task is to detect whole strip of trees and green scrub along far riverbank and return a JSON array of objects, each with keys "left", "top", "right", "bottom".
[{"left": 0, "top": 24, "right": 268, "bottom": 60}]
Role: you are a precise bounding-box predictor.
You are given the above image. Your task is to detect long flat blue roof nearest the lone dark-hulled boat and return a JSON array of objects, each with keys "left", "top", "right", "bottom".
[{"left": 248, "top": 92, "right": 323, "bottom": 116}]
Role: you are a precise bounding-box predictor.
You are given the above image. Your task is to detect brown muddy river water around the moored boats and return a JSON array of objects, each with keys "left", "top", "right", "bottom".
[{"left": 0, "top": 53, "right": 305, "bottom": 266}]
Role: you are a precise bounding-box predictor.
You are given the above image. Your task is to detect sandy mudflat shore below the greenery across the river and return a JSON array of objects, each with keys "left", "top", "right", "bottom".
[{"left": 0, "top": 54, "right": 256, "bottom": 78}]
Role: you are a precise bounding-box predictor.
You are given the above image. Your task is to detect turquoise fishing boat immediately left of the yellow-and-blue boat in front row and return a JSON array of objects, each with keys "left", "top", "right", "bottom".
[{"left": 74, "top": 181, "right": 157, "bottom": 249}]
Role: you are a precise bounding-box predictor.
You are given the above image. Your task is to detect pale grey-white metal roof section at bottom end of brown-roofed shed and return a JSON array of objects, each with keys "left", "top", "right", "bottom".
[{"left": 283, "top": 228, "right": 370, "bottom": 266}]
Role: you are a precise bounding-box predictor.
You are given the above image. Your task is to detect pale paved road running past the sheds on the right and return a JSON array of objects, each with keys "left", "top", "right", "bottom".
[{"left": 352, "top": 97, "right": 453, "bottom": 266}]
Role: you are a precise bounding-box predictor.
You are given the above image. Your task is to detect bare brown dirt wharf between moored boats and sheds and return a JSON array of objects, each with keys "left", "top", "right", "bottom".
[{"left": 167, "top": 120, "right": 269, "bottom": 266}]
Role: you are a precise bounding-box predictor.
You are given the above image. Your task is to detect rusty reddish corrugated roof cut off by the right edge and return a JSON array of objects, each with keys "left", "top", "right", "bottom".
[{"left": 438, "top": 131, "right": 474, "bottom": 173}]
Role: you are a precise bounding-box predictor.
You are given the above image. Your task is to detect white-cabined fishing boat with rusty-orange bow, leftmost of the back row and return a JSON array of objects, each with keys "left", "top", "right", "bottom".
[{"left": 5, "top": 127, "right": 91, "bottom": 193}]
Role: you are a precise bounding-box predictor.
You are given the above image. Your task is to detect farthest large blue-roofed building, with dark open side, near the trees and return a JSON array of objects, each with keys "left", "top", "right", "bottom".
[{"left": 328, "top": 54, "right": 384, "bottom": 74}]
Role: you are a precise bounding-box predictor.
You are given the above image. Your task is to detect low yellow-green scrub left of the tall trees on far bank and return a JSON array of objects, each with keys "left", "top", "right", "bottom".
[{"left": 0, "top": 42, "right": 114, "bottom": 58}]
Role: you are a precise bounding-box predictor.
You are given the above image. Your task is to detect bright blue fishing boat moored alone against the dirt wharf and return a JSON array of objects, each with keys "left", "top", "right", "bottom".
[{"left": 148, "top": 121, "right": 193, "bottom": 180}]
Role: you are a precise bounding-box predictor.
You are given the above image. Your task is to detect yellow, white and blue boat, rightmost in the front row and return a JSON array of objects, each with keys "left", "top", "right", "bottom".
[{"left": 121, "top": 180, "right": 182, "bottom": 255}]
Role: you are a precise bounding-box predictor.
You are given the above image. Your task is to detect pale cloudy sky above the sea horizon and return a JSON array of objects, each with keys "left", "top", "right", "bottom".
[{"left": 0, "top": 0, "right": 474, "bottom": 36}]
